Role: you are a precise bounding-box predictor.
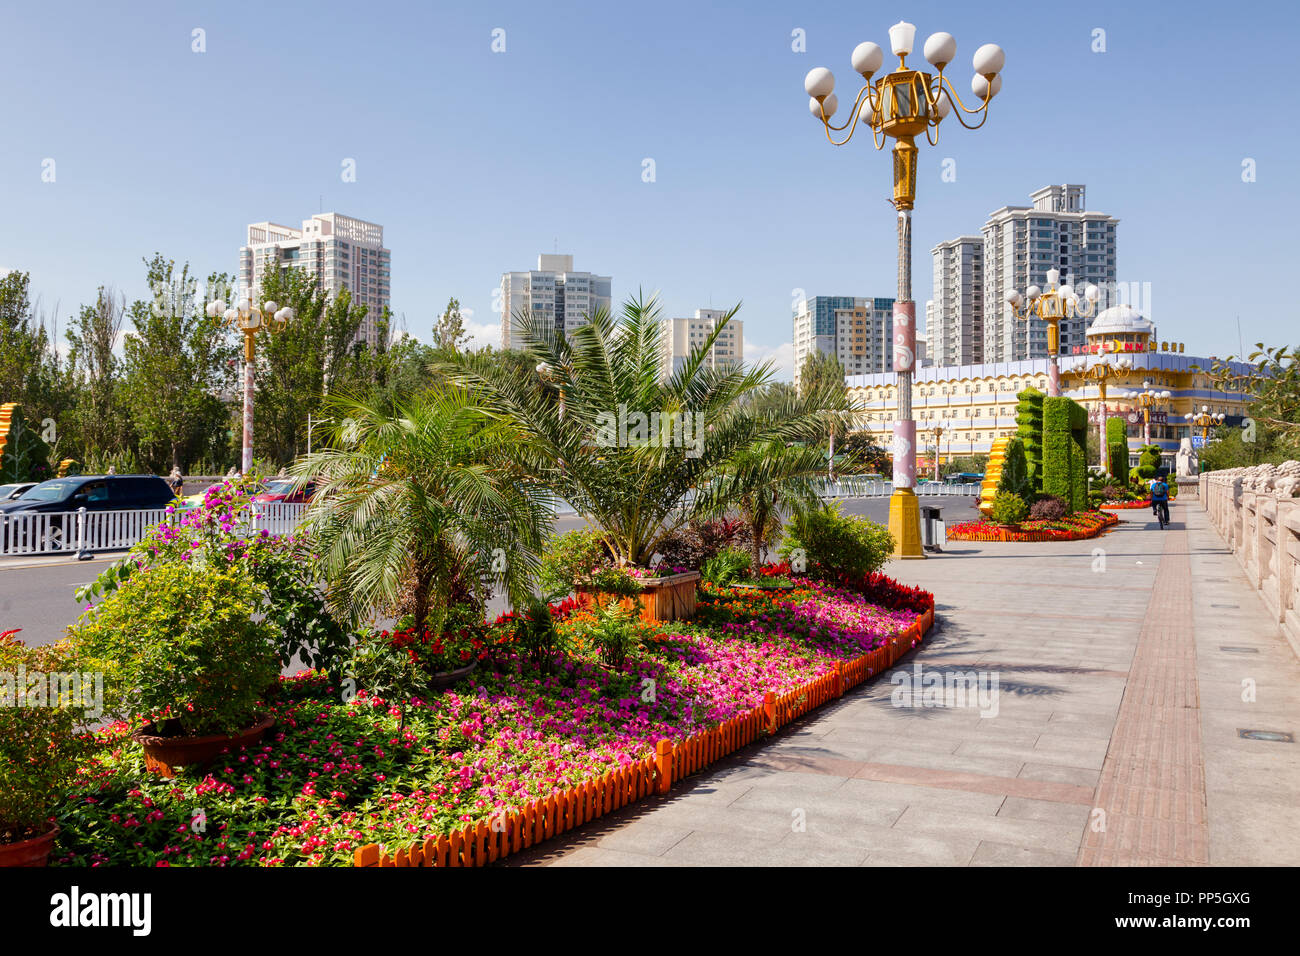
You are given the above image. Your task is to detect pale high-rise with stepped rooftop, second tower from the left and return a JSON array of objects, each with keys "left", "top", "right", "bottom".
[{"left": 501, "top": 255, "right": 612, "bottom": 349}]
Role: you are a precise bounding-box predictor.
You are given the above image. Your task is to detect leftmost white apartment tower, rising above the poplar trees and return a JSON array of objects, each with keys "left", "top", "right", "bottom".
[{"left": 239, "top": 212, "right": 391, "bottom": 346}]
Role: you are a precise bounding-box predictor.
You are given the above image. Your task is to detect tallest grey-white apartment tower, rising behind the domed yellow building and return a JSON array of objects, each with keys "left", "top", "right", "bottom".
[{"left": 982, "top": 185, "right": 1119, "bottom": 362}]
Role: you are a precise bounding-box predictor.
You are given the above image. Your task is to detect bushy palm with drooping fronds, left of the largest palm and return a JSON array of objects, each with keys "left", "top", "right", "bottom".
[{"left": 293, "top": 386, "right": 551, "bottom": 631}]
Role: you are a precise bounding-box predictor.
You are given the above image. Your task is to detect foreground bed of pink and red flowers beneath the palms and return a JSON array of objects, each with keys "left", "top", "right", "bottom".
[{"left": 53, "top": 578, "right": 932, "bottom": 866}]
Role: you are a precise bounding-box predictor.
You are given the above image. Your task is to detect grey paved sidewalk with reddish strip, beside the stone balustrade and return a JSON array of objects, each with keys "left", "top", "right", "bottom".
[{"left": 510, "top": 501, "right": 1300, "bottom": 866}]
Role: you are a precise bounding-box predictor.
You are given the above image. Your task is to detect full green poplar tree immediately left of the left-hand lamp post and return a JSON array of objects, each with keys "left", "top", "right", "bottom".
[{"left": 122, "top": 252, "right": 239, "bottom": 471}]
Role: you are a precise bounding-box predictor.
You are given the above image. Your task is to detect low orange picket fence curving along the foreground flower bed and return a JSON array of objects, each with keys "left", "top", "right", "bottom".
[{"left": 352, "top": 609, "right": 935, "bottom": 866}]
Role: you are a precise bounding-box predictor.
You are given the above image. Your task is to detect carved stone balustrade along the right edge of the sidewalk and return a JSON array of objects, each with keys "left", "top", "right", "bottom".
[{"left": 1199, "top": 462, "right": 1300, "bottom": 656}]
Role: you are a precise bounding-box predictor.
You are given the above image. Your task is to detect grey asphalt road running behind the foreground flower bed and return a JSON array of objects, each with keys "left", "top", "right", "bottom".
[{"left": 0, "top": 497, "right": 976, "bottom": 646}]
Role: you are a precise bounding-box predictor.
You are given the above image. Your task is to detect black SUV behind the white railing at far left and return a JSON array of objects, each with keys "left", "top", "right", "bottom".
[{"left": 0, "top": 475, "right": 173, "bottom": 548}]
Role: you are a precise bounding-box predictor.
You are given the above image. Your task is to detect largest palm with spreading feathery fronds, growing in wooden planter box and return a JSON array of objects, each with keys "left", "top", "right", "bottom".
[{"left": 436, "top": 295, "right": 836, "bottom": 566}]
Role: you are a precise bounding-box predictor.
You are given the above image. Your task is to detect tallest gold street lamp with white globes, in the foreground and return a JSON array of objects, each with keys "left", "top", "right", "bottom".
[{"left": 803, "top": 16, "right": 1006, "bottom": 558}]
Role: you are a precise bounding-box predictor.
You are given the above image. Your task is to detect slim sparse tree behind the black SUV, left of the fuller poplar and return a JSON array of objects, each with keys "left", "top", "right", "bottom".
[{"left": 68, "top": 286, "right": 131, "bottom": 459}]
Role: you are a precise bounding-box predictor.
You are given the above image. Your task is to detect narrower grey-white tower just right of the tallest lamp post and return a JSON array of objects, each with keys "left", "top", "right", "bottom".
[{"left": 926, "top": 235, "right": 984, "bottom": 365}]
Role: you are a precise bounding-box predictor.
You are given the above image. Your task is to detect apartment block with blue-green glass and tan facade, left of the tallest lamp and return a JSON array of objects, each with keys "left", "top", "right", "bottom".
[{"left": 794, "top": 295, "right": 894, "bottom": 388}]
